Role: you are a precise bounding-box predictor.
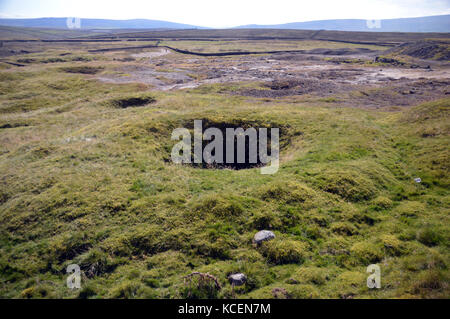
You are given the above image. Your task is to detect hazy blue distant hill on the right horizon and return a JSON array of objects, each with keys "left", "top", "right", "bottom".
[{"left": 237, "top": 15, "right": 450, "bottom": 32}]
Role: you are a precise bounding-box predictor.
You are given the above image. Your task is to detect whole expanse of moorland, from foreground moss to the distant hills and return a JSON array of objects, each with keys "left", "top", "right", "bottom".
[{"left": 0, "top": 27, "right": 450, "bottom": 298}]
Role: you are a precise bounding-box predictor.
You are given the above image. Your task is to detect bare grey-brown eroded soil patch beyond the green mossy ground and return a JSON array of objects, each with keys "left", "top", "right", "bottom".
[{"left": 98, "top": 48, "right": 450, "bottom": 108}]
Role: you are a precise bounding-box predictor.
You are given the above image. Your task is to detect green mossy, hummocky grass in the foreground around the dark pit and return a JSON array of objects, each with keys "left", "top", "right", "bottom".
[{"left": 0, "top": 45, "right": 450, "bottom": 298}]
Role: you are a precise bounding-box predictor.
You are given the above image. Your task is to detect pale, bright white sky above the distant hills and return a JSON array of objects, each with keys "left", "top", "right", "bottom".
[{"left": 0, "top": 0, "right": 450, "bottom": 28}]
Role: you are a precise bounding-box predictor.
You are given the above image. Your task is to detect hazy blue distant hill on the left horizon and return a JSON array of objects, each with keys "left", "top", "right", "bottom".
[{"left": 0, "top": 18, "right": 203, "bottom": 30}]
